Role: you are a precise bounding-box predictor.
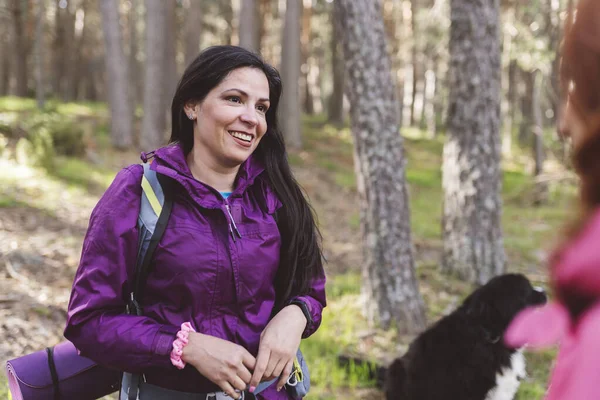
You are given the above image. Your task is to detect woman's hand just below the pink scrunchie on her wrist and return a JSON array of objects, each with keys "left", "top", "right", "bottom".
[{"left": 181, "top": 332, "right": 256, "bottom": 399}]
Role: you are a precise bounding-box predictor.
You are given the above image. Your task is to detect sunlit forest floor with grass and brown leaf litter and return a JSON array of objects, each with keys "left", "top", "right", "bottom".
[{"left": 0, "top": 97, "right": 575, "bottom": 400}]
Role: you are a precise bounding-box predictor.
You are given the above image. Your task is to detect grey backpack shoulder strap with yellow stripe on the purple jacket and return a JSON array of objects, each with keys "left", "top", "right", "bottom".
[{"left": 127, "top": 163, "right": 173, "bottom": 315}]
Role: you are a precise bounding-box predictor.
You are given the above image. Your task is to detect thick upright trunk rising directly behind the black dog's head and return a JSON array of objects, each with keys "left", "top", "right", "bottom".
[{"left": 442, "top": 0, "right": 505, "bottom": 283}]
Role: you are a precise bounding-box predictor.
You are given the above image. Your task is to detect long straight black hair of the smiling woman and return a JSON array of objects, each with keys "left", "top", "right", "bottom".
[{"left": 169, "top": 46, "right": 324, "bottom": 307}]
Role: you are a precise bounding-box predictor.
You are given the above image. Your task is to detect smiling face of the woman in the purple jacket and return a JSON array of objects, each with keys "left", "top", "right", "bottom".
[{"left": 185, "top": 67, "right": 269, "bottom": 168}]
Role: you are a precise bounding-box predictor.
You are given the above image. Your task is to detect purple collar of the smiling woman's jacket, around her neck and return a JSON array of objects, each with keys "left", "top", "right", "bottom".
[{"left": 141, "top": 143, "right": 265, "bottom": 208}]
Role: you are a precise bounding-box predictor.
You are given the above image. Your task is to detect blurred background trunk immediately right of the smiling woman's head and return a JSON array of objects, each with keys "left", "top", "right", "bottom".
[{"left": 279, "top": 0, "right": 302, "bottom": 149}]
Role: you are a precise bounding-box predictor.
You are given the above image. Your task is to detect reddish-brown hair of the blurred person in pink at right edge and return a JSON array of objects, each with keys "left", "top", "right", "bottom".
[{"left": 551, "top": 0, "right": 600, "bottom": 318}]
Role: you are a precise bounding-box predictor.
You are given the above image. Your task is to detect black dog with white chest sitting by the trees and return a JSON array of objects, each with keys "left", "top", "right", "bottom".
[{"left": 385, "top": 274, "right": 546, "bottom": 400}]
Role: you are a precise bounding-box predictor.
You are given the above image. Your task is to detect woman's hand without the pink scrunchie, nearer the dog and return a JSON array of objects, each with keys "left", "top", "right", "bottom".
[{"left": 250, "top": 304, "right": 307, "bottom": 391}]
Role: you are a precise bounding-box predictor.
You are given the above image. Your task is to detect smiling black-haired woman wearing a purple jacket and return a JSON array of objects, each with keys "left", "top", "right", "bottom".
[{"left": 65, "top": 46, "right": 325, "bottom": 400}]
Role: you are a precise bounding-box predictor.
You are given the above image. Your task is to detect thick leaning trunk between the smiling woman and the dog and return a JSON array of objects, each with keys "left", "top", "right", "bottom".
[{"left": 334, "top": 0, "right": 425, "bottom": 333}]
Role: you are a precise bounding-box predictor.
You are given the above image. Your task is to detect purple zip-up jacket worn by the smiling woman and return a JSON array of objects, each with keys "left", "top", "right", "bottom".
[{"left": 65, "top": 145, "right": 325, "bottom": 400}]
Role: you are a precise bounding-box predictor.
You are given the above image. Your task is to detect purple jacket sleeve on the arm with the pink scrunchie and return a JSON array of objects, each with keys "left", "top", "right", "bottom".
[{"left": 64, "top": 165, "right": 179, "bottom": 372}]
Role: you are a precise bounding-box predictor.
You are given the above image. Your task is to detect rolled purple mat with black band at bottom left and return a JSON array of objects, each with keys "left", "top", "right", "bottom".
[{"left": 6, "top": 341, "right": 122, "bottom": 400}]
